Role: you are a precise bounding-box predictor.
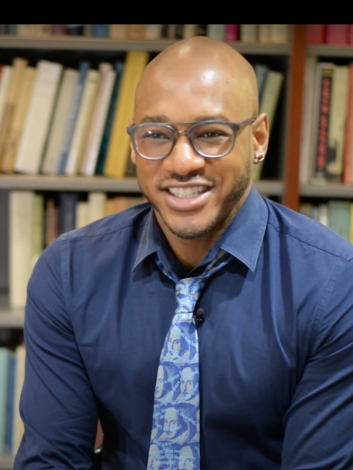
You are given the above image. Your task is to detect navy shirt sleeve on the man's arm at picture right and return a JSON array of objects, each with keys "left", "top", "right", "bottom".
[{"left": 281, "top": 259, "right": 353, "bottom": 470}]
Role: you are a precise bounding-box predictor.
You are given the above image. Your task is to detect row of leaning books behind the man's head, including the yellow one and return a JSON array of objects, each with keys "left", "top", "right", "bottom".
[{"left": 0, "top": 51, "right": 284, "bottom": 179}]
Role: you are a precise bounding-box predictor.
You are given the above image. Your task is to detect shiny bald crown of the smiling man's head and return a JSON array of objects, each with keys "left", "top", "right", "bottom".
[{"left": 135, "top": 36, "right": 258, "bottom": 119}]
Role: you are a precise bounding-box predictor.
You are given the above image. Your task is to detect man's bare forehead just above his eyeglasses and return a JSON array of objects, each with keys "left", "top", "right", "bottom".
[{"left": 134, "top": 66, "right": 248, "bottom": 123}]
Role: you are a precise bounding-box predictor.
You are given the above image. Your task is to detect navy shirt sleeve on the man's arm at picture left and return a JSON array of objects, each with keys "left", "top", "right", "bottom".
[{"left": 14, "top": 238, "right": 98, "bottom": 470}]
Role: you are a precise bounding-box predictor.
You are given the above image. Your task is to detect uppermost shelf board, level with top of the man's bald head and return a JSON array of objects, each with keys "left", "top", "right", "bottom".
[{"left": 0, "top": 35, "right": 291, "bottom": 55}]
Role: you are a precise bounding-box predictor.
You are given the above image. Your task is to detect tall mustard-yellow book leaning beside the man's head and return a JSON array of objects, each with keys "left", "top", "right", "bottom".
[{"left": 104, "top": 51, "right": 149, "bottom": 178}]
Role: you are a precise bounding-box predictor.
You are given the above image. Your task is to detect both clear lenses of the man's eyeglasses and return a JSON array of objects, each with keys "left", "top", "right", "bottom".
[{"left": 135, "top": 123, "right": 234, "bottom": 158}]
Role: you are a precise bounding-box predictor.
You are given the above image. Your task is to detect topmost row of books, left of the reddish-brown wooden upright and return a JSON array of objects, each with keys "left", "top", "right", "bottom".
[{"left": 0, "top": 24, "right": 290, "bottom": 44}]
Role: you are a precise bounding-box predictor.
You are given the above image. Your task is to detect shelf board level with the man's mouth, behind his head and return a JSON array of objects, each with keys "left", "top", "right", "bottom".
[{"left": 0, "top": 175, "right": 283, "bottom": 196}]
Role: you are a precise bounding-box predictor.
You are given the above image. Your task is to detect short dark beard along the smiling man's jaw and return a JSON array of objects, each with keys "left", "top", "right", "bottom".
[{"left": 137, "top": 161, "right": 251, "bottom": 240}]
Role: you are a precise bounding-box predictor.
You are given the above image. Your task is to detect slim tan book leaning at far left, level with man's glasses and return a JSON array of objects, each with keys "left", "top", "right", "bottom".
[{"left": 1, "top": 67, "right": 37, "bottom": 173}]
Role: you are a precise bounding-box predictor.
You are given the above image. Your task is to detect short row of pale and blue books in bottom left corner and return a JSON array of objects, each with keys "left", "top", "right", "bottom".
[{"left": 0, "top": 344, "right": 26, "bottom": 456}]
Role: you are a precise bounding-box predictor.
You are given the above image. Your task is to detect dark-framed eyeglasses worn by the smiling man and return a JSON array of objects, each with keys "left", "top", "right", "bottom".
[{"left": 127, "top": 117, "right": 256, "bottom": 160}]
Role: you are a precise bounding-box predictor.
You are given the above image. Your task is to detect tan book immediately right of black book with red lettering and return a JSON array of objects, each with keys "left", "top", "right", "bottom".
[{"left": 325, "top": 65, "right": 348, "bottom": 182}]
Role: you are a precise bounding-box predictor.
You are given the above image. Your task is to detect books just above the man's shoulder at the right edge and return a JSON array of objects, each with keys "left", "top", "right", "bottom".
[{"left": 299, "top": 199, "right": 353, "bottom": 243}]
